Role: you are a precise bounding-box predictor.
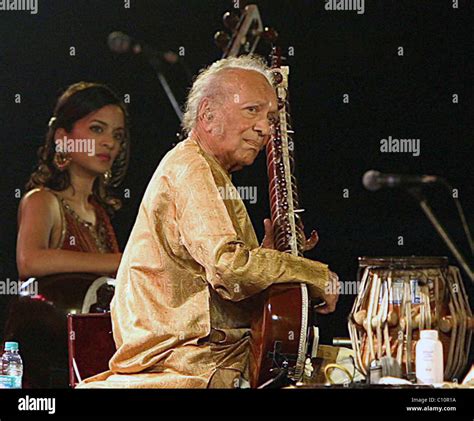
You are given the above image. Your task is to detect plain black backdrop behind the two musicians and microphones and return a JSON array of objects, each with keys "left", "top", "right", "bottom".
[{"left": 0, "top": 0, "right": 474, "bottom": 348}]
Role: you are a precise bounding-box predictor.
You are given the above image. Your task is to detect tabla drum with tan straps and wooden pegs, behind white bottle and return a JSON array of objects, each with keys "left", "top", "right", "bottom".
[{"left": 348, "top": 256, "right": 474, "bottom": 380}]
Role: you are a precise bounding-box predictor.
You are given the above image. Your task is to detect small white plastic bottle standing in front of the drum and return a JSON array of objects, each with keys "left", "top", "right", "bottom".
[{"left": 416, "top": 330, "right": 444, "bottom": 384}]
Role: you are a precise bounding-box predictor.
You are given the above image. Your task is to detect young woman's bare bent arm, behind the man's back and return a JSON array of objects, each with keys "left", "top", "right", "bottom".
[{"left": 16, "top": 190, "right": 122, "bottom": 279}]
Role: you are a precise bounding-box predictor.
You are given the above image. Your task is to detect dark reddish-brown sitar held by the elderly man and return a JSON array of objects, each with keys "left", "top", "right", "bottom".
[{"left": 250, "top": 47, "right": 314, "bottom": 387}]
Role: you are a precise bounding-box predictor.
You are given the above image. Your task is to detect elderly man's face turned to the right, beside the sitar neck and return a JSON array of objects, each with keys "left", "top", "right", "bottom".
[{"left": 207, "top": 69, "right": 278, "bottom": 171}]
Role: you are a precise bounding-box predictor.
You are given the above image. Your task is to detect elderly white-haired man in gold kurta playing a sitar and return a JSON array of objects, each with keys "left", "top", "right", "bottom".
[{"left": 80, "top": 56, "right": 338, "bottom": 388}]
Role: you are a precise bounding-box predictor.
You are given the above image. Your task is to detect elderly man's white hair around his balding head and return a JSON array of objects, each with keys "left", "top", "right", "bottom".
[{"left": 182, "top": 55, "right": 273, "bottom": 134}]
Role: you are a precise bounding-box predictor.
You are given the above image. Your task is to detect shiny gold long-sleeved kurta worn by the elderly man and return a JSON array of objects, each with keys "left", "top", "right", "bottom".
[{"left": 80, "top": 139, "right": 328, "bottom": 388}]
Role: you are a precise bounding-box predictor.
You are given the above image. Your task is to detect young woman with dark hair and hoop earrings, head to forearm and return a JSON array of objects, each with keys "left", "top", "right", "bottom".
[{"left": 17, "top": 82, "right": 129, "bottom": 279}]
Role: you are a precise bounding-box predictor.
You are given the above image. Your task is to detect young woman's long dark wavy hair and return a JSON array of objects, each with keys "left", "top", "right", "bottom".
[{"left": 26, "top": 82, "right": 130, "bottom": 214}]
